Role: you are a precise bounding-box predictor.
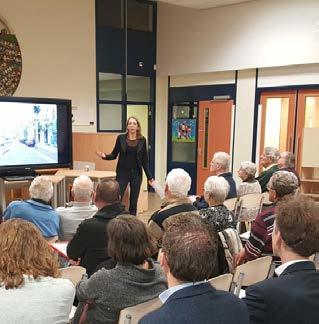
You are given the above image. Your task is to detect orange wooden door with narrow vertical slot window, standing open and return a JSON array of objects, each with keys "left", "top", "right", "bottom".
[{"left": 197, "top": 100, "right": 233, "bottom": 195}]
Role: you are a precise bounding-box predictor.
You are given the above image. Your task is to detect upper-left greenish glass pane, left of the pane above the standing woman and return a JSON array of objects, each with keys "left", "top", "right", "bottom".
[{"left": 99, "top": 73, "right": 123, "bottom": 101}]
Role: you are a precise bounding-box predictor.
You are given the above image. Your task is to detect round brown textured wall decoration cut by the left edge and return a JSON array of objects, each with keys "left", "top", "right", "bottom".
[{"left": 0, "top": 17, "right": 22, "bottom": 96}]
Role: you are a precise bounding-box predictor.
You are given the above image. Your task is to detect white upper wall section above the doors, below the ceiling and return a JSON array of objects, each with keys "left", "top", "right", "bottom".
[{"left": 157, "top": 0, "right": 319, "bottom": 75}]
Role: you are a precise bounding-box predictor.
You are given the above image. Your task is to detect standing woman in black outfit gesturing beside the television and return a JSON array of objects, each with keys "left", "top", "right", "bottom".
[{"left": 96, "top": 117, "right": 154, "bottom": 215}]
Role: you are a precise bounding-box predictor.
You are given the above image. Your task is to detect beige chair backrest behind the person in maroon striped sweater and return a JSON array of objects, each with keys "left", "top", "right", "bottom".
[{"left": 233, "top": 256, "right": 272, "bottom": 286}]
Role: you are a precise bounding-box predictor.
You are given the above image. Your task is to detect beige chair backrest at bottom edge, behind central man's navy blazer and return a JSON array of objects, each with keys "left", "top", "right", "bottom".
[{"left": 118, "top": 298, "right": 162, "bottom": 324}]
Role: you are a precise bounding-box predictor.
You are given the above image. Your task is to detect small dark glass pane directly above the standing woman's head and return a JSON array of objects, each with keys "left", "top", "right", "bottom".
[{"left": 126, "top": 75, "right": 151, "bottom": 102}]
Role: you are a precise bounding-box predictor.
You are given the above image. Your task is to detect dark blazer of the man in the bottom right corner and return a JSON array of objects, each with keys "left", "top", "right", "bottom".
[{"left": 244, "top": 261, "right": 319, "bottom": 324}]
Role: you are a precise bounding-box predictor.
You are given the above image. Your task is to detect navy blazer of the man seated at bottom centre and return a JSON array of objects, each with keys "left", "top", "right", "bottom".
[{"left": 139, "top": 283, "right": 249, "bottom": 324}]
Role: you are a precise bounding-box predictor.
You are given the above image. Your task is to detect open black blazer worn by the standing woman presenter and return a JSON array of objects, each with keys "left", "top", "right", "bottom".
[{"left": 103, "top": 133, "right": 153, "bottom": 180}]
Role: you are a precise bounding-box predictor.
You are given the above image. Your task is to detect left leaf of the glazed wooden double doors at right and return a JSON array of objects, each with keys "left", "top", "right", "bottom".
[{"left": 258, "top": 91, "right": 297, "bottom": 171}]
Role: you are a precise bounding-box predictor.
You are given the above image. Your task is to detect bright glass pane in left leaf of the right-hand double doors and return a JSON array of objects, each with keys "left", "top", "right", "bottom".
[{"left": 264, "top": 98, "right": 289, "bottom": 151}]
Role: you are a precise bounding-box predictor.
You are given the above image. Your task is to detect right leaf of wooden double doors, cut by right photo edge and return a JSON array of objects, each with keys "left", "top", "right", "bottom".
[{"left": 295, "top": 90, "right": 319, "bottom": 172}]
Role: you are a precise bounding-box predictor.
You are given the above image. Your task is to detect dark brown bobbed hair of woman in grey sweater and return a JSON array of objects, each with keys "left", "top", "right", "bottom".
[{"left": 107, "top": 215, "right": 156, "bottom": 265}]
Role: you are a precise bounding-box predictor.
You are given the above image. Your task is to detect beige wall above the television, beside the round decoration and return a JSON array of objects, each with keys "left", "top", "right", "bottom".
[{"left": 0, "top": 0, "right": 96, "bottom": 132}]
